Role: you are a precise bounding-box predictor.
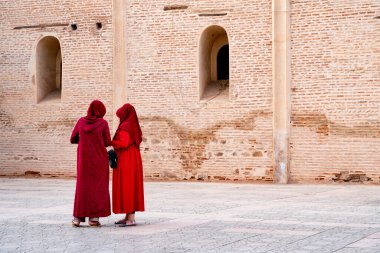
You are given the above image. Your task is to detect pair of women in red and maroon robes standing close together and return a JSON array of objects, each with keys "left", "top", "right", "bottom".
[{"left": 70, "top": 100, "right": 144, "bottom": 226}]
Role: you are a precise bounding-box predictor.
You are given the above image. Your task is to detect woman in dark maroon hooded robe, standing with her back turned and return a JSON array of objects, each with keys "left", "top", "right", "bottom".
[{"left": 70, "top": 100, "right": 111, "bottom": 227}]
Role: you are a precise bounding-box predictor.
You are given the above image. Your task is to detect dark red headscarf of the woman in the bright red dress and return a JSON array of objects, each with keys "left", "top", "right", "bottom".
[{"left": 113, "top": 104, "right": 142, "bottom": 147}]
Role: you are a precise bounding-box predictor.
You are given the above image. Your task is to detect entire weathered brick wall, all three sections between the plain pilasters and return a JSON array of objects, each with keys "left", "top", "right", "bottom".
[{"left": 0, "top": 0, "right": 380, "bottom": 182}]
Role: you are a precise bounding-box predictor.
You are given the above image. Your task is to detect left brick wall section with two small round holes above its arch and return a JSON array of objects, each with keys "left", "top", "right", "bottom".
[{"left": 0, "top": 0, "right": 113, "bottom": 175}]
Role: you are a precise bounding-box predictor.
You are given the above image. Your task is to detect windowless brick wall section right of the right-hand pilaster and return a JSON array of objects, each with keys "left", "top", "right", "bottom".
[{"left": 290, "top": 0, "right": 380, "bottom": 182}]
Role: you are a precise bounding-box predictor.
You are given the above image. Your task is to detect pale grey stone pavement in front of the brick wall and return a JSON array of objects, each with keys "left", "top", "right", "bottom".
[{"left": 0, "top": 178, "right": 380, "bottom": 253}]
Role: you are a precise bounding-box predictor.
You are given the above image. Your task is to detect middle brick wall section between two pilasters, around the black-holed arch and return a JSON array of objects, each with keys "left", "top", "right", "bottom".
[{"left": 126, "top": 0, "right": 273, "bottom": 181}]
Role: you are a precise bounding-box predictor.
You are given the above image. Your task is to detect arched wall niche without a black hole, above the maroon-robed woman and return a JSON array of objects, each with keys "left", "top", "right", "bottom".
[{"left": 36, "top": 36, "right": 62, "bottom": 103}]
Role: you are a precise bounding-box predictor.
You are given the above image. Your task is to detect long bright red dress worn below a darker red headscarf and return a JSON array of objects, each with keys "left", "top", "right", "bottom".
[{"left": 112, "top": 131, "right": 145, "bottom": 213}]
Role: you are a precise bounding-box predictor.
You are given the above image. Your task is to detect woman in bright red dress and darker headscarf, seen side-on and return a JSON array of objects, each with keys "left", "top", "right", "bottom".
[{"left": 112, "top": 104, "right": 145, "bottom": 227}]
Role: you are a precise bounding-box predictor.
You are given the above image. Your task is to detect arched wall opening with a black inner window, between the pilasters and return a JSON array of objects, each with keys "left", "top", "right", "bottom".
[{"left": 199, "top": 25, "right": 230, "bottom": 100}]
